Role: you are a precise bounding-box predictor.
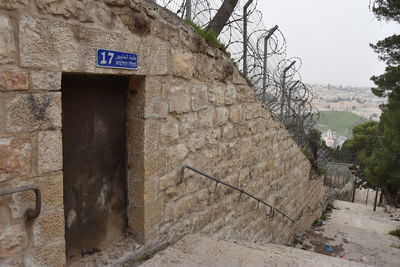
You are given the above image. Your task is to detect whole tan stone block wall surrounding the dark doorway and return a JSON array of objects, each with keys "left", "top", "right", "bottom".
[{"left": 0, "top": 0, "right": 323, "bottom": 266}]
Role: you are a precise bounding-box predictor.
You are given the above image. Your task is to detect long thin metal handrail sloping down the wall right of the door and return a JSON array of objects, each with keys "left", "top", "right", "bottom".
[{"left": 178, "top": 165, "right": 330, "bottom": 224}]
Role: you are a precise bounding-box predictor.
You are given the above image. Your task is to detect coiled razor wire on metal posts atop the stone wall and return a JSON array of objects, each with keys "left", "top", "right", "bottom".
[{"left": 157, "top": 0, "right": 319, "bottom": 146}]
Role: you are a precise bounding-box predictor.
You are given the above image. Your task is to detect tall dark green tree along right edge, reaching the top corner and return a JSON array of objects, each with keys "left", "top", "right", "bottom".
[{"left": 364, "top": 0, "right": 400, "bottom": 204}]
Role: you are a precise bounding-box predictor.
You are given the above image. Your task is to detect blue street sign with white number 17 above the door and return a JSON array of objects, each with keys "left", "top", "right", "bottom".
[{"left": 96, "top": 49, "right": 138, "bottom": 70}]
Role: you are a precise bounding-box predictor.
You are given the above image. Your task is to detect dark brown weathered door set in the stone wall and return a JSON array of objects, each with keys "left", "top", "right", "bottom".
[{"left": 62, "top": 74, "right": 128, "bottom": 262}]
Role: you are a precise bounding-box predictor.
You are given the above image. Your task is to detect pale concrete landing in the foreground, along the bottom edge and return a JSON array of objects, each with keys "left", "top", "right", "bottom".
[{"left": 140, "top": 235, "right": 366, "bottom": 267}]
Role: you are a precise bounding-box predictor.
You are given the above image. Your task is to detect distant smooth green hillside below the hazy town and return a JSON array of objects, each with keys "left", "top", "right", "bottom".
[{"left": 316, "top": 110, "right": 368, "bottom": 137}]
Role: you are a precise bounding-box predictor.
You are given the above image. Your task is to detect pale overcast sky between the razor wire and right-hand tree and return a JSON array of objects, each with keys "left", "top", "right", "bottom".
[{"left": 258, "top": 0, "right": 400, "bottom": 86}]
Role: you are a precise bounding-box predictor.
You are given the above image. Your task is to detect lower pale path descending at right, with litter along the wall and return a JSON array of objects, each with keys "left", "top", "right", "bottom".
[{"left": 296, "top": 200, "right": 400, "bottom": 267}]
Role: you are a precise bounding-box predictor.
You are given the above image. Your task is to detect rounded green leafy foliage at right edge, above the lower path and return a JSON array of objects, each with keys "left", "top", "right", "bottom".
[{"left": 342, "top": 116, "right": 400, "bottom": 204}]
